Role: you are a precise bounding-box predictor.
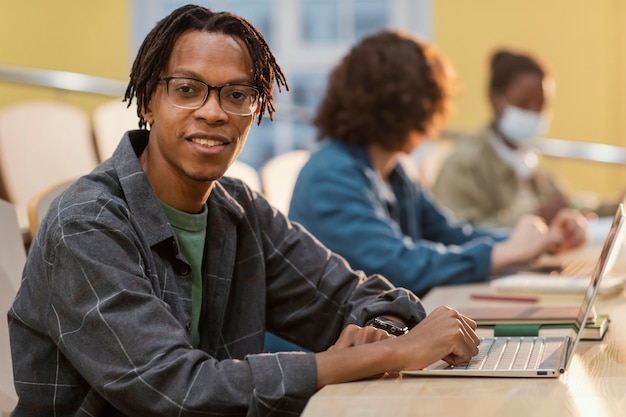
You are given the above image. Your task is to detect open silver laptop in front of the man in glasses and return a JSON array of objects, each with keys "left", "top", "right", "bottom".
[{"left": 402, "top": 204, "right": 626, "bottom": 378}]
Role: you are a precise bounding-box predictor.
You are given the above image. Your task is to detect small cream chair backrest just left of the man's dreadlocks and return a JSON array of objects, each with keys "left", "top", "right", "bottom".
[{"left": 92, "top": 99, "right": 139, "bottom": 161}]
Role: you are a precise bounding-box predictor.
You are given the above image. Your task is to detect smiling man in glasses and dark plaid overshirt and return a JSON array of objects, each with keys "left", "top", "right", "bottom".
[{"left": 8, "top": 5, "right": 479, "bottom": 417}]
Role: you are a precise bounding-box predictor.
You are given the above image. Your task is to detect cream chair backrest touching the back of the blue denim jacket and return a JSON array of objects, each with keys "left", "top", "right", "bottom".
[{"left": 261, "top": 149, "right": 310, "bottom": 214}]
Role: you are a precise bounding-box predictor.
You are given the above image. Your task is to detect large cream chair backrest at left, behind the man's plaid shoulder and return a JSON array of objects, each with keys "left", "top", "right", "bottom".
[{"left": 0, "top": 100, "right": 98, "bottom": 230}]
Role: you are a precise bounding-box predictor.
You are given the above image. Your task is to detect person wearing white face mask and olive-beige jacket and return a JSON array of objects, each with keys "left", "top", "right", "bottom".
[{"left": 432, "top": 50, "right": 569, "bottom": 227}]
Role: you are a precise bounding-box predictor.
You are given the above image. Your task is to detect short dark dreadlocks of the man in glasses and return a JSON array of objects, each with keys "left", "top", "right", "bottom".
[{"left": 124, "top": 4, "right": 289, "bottom": 128}]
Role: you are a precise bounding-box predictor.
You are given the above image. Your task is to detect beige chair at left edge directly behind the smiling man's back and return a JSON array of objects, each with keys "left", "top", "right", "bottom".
[{"left": 0, "top": 200, "right": 26, "bottom": 415}]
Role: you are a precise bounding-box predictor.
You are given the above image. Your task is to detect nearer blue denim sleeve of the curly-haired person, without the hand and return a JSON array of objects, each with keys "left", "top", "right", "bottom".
[{"left": 289, "top": 161, "right": 495, "bottom": 294}]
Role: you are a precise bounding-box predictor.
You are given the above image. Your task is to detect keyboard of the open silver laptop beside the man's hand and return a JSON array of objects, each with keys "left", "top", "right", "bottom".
[{"left": 455, "top": 337, "right": 565, "bottom": 370}]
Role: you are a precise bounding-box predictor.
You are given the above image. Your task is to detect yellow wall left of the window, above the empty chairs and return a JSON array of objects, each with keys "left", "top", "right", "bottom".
[{"left": 0, "top": 0, "right": 130, "bottom": 112}]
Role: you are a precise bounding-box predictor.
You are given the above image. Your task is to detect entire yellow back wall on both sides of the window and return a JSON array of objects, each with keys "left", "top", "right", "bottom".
[{"left": 0, "top": 0, "right": 626, "bottom": 198}]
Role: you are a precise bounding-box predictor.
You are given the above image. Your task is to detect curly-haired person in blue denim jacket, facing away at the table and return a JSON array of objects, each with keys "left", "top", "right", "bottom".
[{"left": 289, "top": 31, "right": 586, "bottom": 295}]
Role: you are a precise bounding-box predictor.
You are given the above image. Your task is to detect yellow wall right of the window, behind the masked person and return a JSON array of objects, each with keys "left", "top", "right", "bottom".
[{"left": 432, "top": 0, "right": 626, "bottom": 195}]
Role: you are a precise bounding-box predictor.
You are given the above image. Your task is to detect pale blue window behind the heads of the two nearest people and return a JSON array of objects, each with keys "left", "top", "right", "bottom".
[{"left": 129, "top": 0, "right": 431, "bottom": 168}]
